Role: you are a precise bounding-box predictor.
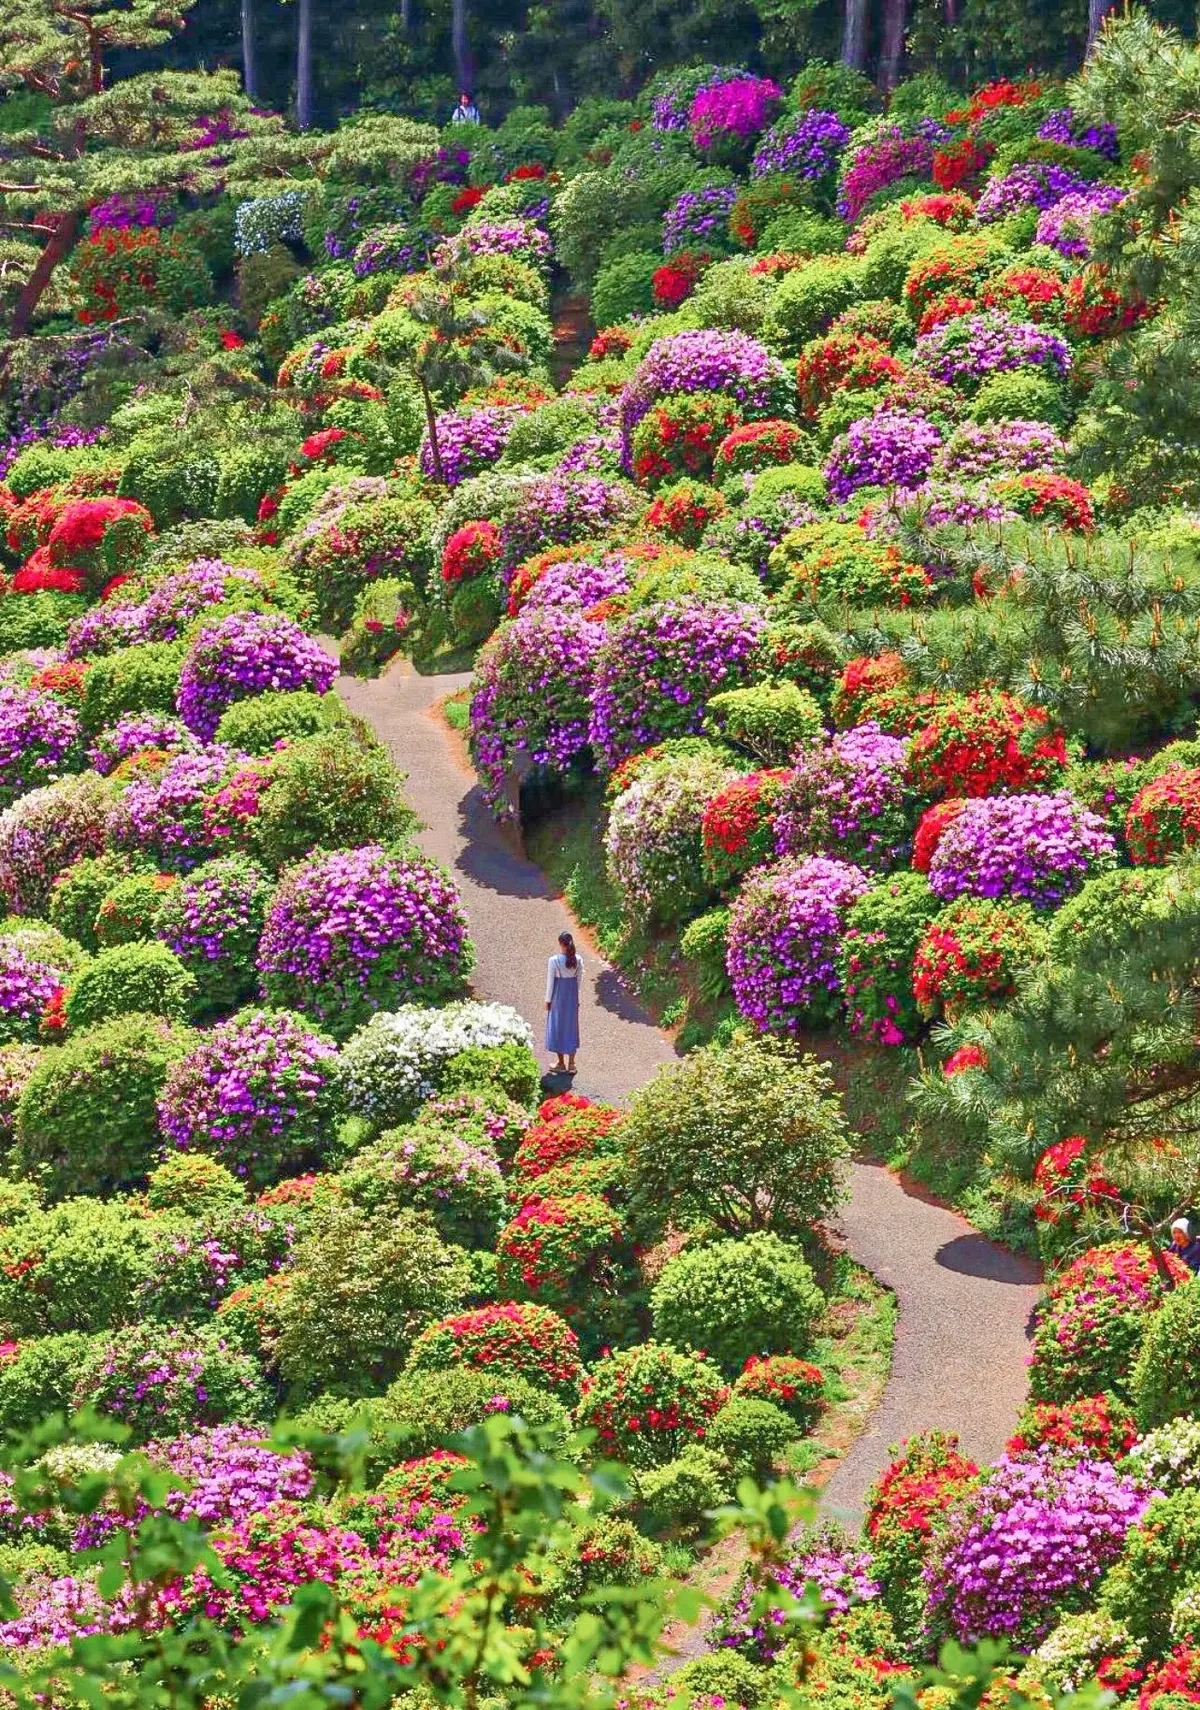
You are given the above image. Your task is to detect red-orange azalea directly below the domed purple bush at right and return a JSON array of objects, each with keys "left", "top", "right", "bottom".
[{"left": 913, "top": 896, "right": 1044, "bottom": 1021}]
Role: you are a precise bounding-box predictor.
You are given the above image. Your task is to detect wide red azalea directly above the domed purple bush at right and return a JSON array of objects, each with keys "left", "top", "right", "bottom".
[{"left": 908, "top": 689, "right": 1068, "bottom": 799}]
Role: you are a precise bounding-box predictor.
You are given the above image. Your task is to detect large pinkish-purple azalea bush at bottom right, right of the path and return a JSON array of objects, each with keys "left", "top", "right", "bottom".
[{"left": 925, "top": 1450, "right": 1150, "bottom": 1647}]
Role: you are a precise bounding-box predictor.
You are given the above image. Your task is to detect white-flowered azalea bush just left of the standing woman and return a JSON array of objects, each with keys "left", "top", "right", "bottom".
[{"left": 338, "top": 1000, "right": 533, "bottom": 1129}]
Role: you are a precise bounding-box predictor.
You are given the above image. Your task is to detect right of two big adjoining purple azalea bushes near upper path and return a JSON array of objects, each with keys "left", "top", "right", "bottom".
[{"left": 588, "top": 600, "right": 764, "bottom": 770}]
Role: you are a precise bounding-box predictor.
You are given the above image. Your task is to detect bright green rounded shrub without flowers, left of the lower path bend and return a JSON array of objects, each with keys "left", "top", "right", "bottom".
[{"left": 650, "top": 1233, "right": 824, "bottom": 1377}]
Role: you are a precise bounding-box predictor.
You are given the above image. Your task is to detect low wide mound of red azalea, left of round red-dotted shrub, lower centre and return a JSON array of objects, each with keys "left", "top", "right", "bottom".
[{"left": 405, "top": 1300, "right": 583, "bottom": 1402}]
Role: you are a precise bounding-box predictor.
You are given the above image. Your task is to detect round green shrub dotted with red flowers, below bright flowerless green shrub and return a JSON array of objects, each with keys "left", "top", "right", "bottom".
[{"left": 576, "top": 1342, "right": 728, "bottom": 1467}]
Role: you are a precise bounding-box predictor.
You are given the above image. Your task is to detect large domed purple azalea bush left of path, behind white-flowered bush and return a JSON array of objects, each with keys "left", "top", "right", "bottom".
[{"left": 258, "top": 843, "right": 475, "bottom": 1038}]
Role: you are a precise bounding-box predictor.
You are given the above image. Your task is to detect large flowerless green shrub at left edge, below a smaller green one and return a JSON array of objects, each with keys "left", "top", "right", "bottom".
[{"left": 17, "top": 1016, "right": 188, "bottom": 1197}]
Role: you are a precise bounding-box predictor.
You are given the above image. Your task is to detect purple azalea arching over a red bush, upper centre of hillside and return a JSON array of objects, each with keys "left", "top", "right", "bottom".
[{"left": 621, "top": 327, "right": 795, "bottom": 469}]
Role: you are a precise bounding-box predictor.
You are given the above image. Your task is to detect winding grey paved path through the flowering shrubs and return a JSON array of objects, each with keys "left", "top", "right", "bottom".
[{"left": 338, "top": 665, "right": 1038, "bottom": 1525}]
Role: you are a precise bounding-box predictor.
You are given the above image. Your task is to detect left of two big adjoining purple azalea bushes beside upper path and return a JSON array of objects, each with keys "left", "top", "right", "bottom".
[{"left": 470, "top": 608, "right": 605, "bottom": 812}]
